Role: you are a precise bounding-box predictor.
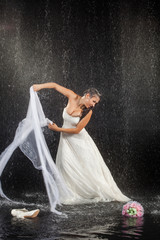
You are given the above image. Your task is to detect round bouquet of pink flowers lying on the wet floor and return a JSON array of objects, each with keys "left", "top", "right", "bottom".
[{"left": 122, "top": 201, "right": 144, "bottom": 217}]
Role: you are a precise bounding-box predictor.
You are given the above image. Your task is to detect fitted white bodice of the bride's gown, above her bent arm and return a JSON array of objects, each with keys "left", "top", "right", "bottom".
[{"left": 63, "top": 108, "right": 80, "bottom": 128}]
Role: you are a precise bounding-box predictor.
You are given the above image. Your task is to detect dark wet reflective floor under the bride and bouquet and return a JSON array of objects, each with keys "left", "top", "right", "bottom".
[{"left": 0, "top": 195, "right": 160, "bottom": 240}]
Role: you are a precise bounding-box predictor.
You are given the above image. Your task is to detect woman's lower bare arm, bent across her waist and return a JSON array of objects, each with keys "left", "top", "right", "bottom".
[{"left": 48, "top": 110, "right": 92, "bottom": 134}]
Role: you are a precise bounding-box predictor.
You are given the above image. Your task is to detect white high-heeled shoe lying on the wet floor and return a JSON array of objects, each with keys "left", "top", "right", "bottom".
[{"left": 11, "top": 208, "right": 40, "bottom": 218}]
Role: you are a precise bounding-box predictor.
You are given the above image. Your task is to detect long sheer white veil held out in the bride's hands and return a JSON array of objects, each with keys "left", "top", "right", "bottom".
[{"left": 0, "top": 87, "right": 70, "bottom": 214}]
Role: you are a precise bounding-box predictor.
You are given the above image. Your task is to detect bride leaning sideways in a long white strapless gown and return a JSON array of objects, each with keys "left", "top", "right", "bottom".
[{"left": 33, "top": 82, "right": 130, "bottom": 204}]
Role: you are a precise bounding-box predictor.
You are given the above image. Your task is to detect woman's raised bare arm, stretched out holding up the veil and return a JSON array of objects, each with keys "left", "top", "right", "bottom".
[{"left": 33, "top": 82, "right": 77, "bottom": 98}]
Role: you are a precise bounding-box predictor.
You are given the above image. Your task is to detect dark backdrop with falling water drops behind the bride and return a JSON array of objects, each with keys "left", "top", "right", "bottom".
[{"left": 0, "top": 0, "right": 160, "bottom": 197}]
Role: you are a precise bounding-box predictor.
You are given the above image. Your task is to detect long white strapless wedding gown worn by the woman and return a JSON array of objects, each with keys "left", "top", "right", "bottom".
[{"left": 56, "top": 108, "right": 130, "bottom": 204}]
